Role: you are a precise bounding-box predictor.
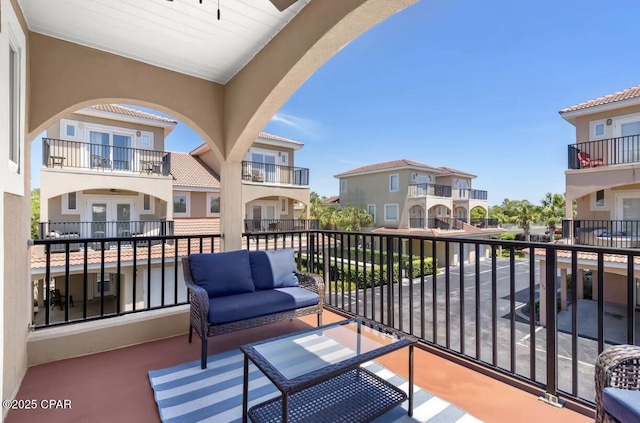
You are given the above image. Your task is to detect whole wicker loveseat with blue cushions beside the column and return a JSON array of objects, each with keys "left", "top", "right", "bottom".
[{"left": 182, "top": 249, "right": 324, "bottom": 369}]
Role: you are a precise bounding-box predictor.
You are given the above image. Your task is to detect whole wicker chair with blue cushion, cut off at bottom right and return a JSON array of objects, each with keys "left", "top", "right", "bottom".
[{"left": 595, "top": 345, "right": 640, "bottom": 423}]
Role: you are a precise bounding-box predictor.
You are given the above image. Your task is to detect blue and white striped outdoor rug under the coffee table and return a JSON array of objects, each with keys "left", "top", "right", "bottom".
[{"left": 149, "top": 336, "right": 480, "bottom": 423}]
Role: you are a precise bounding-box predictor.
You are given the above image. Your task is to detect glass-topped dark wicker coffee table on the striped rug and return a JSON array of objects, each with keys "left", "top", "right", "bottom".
[{"left": 240, "top": 318, "right": 417, "bottom": 423}]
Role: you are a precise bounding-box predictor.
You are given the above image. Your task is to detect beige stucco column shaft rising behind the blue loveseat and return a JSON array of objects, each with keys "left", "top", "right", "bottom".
[{"left": 220, "top": 161, "right": 244, "bottom": 251}]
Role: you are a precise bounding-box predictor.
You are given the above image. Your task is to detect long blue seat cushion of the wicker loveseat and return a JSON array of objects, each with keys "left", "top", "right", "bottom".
[{"left": 208, "top": 287, "right": 319, "bottom": 324}]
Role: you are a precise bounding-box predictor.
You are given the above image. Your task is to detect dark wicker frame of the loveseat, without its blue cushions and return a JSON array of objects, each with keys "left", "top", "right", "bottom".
[{"left": 182, "top": 257, "right": 324, "bottom": 369}]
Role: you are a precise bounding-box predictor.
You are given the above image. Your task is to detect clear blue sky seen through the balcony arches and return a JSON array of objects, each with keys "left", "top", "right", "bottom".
[{"left": 33, "top": 0, "right": 640, "bottom": 205}]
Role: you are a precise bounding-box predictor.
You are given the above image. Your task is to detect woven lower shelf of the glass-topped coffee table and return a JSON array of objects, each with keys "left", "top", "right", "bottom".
[{"left": 249, "top": 368, "right": 407, "bottom": 423}]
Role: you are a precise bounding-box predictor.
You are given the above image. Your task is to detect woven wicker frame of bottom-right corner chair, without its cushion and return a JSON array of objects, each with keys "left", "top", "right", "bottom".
[{"left": 595, "top": 345, "right": 640, "bottom": 423}]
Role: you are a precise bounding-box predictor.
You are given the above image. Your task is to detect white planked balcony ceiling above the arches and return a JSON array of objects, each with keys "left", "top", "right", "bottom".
[{"left": 19, "top": 0, "right": 311, "bottom": 84}]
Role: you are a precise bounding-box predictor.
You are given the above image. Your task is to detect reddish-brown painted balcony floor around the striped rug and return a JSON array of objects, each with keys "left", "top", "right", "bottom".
[{"left": 6, "top": 311, "right": 593, "bottom": 423}]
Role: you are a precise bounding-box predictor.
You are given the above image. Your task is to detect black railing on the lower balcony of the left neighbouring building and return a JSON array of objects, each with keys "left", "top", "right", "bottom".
[{"left": 38, "top": 220, "right": 173, "bottom": 239}]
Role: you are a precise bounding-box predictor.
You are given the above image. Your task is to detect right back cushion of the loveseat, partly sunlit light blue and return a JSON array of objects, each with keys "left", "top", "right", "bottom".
[{"left": 249, "top": 248, "right": 298, "bottom": 290}]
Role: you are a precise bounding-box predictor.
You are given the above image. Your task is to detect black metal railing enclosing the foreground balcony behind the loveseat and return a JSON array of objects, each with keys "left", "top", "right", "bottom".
[{"left": 32, "top": 231, "right": 640, "bottom": 407}]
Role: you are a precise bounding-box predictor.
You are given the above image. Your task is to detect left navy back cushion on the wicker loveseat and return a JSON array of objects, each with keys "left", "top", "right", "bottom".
[{"left": 189, "top": 250, "right": 255, "bottom": 298}]
